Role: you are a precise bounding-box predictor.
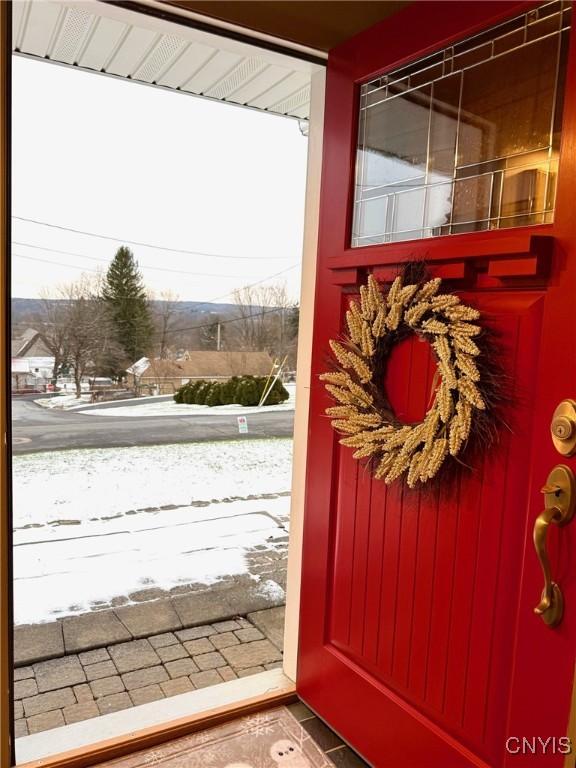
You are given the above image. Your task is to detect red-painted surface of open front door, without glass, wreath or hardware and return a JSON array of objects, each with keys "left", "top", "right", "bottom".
[{"left": 298, "top": 2, "right": 576, "bottom": 768}]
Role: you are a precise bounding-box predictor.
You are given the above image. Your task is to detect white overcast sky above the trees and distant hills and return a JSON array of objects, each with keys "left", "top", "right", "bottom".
[{"left": 12, "top": 56, "right": 307, "bottom": 301}]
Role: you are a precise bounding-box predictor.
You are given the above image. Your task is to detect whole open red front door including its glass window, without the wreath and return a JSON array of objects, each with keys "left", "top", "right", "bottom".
[{"left": 298, "top": 2, "right": 576, "bottom": 768}]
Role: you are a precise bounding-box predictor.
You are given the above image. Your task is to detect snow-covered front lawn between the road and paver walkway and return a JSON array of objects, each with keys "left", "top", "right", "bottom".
[{"left": 13, "top": 439, "right": 292, "bottom": 624}]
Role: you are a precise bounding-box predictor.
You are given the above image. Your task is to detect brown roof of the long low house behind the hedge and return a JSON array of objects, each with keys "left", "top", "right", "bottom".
[{"left": 135, "top": 351, "right": 273, "bottom": 379}]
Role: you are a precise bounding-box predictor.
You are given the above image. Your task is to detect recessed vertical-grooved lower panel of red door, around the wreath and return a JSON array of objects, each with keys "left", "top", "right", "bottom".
[{"left": 324, "top": 292, "right": 543, "bottom": 765}]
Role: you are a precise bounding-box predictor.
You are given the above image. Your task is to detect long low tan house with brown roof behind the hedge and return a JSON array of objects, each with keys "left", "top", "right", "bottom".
[{"left": 127, "top": 351, "right": 273, "bottom": 395}]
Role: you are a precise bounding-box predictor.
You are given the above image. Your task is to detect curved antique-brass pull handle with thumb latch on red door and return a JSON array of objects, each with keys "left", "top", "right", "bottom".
[{"left": 534, "top": 464, "right": 576, "bottom": 627}]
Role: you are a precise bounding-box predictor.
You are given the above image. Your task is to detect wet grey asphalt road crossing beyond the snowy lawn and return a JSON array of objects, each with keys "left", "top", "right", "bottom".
[{"left": 12, "top": 399, "right": 294, "bottom": 454}]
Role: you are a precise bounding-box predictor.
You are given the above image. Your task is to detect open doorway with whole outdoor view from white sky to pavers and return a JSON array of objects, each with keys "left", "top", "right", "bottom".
[{"left": 12, "top": 3, "right": 324, "bottom": 756}]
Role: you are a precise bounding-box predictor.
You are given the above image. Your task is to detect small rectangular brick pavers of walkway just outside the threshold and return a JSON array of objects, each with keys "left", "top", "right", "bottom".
[{"left": 14, "top": 607, "right": 284, "bottom": 738}]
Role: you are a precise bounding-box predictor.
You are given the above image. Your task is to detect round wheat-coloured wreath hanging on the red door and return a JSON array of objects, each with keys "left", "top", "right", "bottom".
[{"left": 320, "top": 263, "right": 502, "bottom": 488}]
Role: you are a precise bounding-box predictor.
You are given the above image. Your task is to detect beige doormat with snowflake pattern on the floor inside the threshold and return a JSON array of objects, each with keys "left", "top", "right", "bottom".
[{"left": 101, "top": 707, "right": 334, "bottom": 768}]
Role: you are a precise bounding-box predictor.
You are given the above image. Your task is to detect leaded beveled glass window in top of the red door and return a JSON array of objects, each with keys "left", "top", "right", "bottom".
[{"left": 352, "top": 0, "right": 571, "bottom": 246}]
